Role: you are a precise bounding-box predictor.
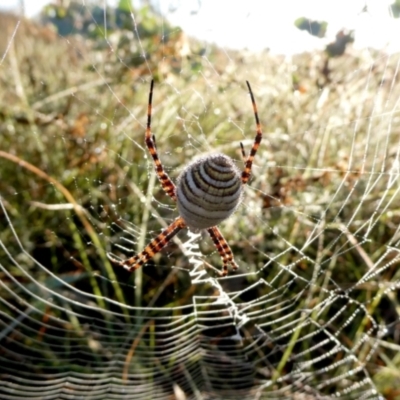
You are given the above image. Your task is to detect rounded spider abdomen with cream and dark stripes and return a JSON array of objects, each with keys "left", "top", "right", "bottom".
[{"left": 176, "top": 154, "right": 243, "bottom": 231}]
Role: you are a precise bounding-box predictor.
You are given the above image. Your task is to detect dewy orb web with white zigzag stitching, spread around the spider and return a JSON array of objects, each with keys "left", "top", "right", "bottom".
[{"left": 0, "top": 2, "right": 400, "bottom": 399}]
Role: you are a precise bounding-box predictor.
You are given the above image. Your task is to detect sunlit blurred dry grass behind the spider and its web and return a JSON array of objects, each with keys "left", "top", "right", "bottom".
[{"left": 0, "top": 8, "right": 400, "bottom": 398}]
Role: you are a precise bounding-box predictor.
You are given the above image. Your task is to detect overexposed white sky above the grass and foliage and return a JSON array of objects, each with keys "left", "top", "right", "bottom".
[{"left": 0, "top": 0, "right": 400, "bottom": 54}]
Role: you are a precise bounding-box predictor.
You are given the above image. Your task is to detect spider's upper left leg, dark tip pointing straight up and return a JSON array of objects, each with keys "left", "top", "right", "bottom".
[{"left": 145, "top": 80, "right": 176, "bottom": 201}]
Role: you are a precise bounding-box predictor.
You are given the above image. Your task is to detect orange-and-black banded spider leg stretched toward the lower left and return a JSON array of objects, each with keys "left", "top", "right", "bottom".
[{"left": 107, "top": 217, "right": 186, "bottom": 272}]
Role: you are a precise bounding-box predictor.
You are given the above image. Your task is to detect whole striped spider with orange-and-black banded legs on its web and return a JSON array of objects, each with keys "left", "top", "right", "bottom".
[{"left": 107, "top": 80, "right": 262, "bottom": 276}]
